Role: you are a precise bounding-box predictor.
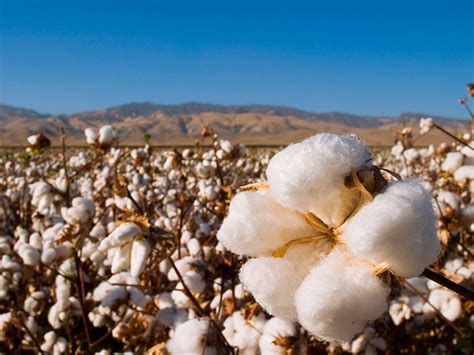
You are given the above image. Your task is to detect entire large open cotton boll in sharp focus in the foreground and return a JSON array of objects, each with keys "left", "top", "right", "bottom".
[{"left": 218, "top": 134, "right": 440, "bottom": 342}]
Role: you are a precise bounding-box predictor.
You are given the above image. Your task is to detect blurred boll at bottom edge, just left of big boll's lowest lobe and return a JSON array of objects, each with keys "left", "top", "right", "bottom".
[{"left": 258, "top": 317, "right": 297, "bottom": 355}]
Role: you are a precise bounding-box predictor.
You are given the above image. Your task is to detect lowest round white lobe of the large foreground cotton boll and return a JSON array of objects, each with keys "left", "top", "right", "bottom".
[{"left": 295, "top": 249, "right": 390, "bottom": 343}]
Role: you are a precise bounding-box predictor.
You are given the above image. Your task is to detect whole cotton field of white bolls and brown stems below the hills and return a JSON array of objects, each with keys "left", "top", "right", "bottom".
[{"left": 0, "top": 118, "right": 474, "bottom": 354}]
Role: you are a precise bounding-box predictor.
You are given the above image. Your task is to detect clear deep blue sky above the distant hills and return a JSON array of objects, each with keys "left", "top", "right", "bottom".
[{"left": 0, "top": 0, "right": 474, "bottom": 117}]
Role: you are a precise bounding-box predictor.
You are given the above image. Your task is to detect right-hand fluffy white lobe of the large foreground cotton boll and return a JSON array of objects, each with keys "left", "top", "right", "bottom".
[{"left": 343, "top": 180, "right": 440, "bottom": 277}]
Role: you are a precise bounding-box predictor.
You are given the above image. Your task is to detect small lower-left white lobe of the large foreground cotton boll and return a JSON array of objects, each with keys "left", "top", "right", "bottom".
[{"left": 240, "top": 257, "right": 301, "bottom": 319}]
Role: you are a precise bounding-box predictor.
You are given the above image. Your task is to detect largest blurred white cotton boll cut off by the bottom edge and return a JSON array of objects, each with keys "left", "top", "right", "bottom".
[{"left": 166, "top": 319, "right": 216, "bottom": 355}]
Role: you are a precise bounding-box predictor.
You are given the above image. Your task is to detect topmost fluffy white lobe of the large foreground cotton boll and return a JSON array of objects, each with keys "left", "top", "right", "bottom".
[{"left": 267, "top": 133, "right": 371, "bottom": 227}]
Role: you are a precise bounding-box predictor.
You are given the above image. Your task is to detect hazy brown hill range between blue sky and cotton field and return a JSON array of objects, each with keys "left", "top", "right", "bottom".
[{"left": 0, "top": 102, "right": 467, "bottom": 146}]
